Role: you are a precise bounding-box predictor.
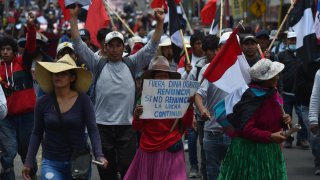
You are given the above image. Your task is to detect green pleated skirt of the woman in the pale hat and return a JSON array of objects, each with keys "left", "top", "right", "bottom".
[{"left": 218, "top": 138, "right": 287, "bottom": 180}]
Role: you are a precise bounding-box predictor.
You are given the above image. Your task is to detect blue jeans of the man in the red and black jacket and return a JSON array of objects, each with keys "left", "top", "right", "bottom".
[{"left": 0, "top": 112, "right": 37, "bottom": 180}]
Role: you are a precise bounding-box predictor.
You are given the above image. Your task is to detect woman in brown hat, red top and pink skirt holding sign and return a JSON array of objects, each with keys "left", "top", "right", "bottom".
[{"left": 124, "top": 56, "right": 193, "bottom": 180}]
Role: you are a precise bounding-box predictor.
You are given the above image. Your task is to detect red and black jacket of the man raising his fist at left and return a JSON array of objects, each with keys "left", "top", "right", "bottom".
[{"left": 0, "top": 25, "right": 36, "bottom": 115}]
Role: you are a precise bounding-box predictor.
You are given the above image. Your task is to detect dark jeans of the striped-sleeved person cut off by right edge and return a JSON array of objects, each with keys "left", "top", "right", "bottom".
[{"left": 301, "top": 106, "right": 320, "bottom": 168}]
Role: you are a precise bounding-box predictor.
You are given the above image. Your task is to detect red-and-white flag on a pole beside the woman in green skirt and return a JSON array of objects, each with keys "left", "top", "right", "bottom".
[{"left": 203, "top": 28, "right": 251, "bottom": 93}]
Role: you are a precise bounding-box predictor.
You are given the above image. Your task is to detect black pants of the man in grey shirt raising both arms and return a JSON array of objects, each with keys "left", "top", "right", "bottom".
[{"left": 98, "top": 125, "right": 137, "bottom": 180}]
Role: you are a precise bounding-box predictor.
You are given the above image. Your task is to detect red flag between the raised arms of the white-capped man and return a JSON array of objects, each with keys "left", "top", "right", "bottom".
[{"left": 85, "top": 0, "right": 110, "bottom": 48}]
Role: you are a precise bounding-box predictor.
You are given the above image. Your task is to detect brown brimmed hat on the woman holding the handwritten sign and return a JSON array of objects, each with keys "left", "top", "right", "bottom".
[{"left": 141, "top": 56, "right": 181, "bottom": 79}]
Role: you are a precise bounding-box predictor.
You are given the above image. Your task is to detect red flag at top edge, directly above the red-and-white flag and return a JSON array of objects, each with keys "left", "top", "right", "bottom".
[{"left": 201, "top": 0, "right": 217, "bottom": 25}]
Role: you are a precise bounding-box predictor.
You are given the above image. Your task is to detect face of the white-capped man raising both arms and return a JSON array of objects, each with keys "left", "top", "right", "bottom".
[{"left": 105, "top": 38, "right": 124, "bottom": 61}]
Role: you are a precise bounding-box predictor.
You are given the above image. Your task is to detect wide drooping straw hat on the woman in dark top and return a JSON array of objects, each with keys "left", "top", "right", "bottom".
[{"left": 35, "top": 54, "right": 92, "bottom": 93}]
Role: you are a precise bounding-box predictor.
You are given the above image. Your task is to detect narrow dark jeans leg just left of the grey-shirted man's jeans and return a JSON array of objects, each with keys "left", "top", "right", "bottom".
[{"left": 197, "top": 121, "right": 207, "bottom": 180}]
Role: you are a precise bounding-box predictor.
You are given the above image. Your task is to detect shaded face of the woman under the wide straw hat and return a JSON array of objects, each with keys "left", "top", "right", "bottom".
[{"left": 52, "top": 71, "right": 76, "bottom": 88}]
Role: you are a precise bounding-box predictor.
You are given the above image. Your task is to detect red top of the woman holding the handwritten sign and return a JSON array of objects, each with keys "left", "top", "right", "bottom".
[{"left": 132, "top": 108, "right": 193, "bottom": 152}]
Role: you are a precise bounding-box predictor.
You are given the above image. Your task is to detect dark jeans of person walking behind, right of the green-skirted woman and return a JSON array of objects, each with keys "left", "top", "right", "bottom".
[{"left": 283, "top": 94, "right": 308, "bottom": 141}]
